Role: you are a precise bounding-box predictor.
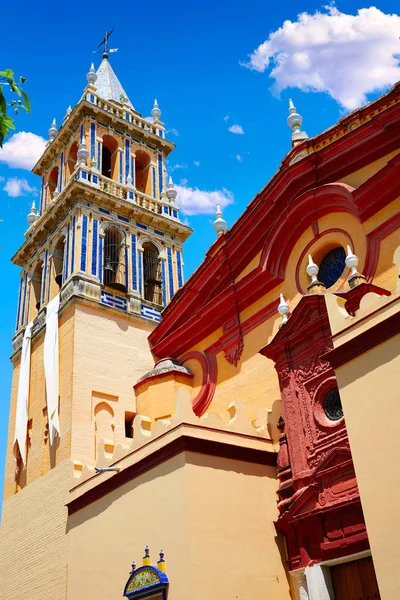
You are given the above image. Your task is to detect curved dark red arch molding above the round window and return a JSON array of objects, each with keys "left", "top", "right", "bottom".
[{"left": 260, "top": 183, "right": 360, "bottom": 279}]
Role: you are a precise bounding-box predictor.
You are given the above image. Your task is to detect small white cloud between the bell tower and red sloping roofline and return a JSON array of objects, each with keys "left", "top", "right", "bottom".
[{"left": 175, "top": 185, "right": 233, "bottom": 215}]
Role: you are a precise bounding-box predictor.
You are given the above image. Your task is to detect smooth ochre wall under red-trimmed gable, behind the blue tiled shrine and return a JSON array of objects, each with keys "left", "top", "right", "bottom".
[{"left": 68, "top": 452, "right": 290, "bottom": 600}]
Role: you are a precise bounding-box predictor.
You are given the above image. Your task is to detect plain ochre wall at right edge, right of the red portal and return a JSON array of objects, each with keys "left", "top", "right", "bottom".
[{"left": 336, "top": 335, "right": 400, "bottom": 600}]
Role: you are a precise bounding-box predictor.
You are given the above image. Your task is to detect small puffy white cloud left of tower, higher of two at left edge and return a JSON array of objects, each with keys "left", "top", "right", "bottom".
[{"left": 0, "top": 131, "right": 46, "bottom": 170}]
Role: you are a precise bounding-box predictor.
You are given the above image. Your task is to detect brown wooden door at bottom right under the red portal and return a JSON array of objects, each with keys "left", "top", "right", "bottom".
[{"left": 331, "top": 556, "right": 380, "bottom": 600}]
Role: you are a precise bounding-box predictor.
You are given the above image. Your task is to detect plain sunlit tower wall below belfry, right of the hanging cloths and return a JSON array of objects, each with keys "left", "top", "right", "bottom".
[{"left": 71, "top": 304, "right": 154, "bottom": 465}]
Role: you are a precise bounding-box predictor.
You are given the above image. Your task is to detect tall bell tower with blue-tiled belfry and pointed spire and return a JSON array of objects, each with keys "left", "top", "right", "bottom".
[{"left": 3, "top": 52, "right": 191, "bottom": 598}]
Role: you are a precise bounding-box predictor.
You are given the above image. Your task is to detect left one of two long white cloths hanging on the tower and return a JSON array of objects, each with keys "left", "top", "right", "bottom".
[{"left": 13, "top": 321, "right": 33, "bottom": 466}]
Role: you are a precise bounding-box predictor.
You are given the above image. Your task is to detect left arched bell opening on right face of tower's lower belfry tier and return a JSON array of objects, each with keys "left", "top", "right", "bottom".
[{"left": 103, "top": 227, "right": 126, "bottom": 292}]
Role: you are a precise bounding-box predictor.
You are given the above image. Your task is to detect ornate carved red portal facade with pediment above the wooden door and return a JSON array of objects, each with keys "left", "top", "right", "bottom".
[{"left": 261, "top": 295, "right": 369, "bottom": 570}]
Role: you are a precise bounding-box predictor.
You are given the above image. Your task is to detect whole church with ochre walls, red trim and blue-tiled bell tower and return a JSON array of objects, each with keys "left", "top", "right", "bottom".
[{"left": 0, "top": 49, "right": 400, "bottom": 600}]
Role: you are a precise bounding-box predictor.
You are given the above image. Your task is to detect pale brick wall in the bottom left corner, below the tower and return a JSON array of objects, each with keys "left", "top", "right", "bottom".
[{"left": 0, "top": 460, "right": 70, "bottom": 600}]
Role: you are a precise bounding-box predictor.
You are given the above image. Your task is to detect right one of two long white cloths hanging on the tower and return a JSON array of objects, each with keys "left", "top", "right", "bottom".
[{"left": 43, "top": 293, "right": 60, "bottom": 444}]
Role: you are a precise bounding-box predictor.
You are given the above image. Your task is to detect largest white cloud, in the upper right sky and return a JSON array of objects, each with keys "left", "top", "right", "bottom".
[{"left": 245, "top": 5, "right": 400, "bottom": 110}]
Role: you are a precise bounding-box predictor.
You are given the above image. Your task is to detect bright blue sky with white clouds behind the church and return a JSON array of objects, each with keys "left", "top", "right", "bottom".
[{"left": 0, "top": 0, "right": 400, "bottom": 508}]
